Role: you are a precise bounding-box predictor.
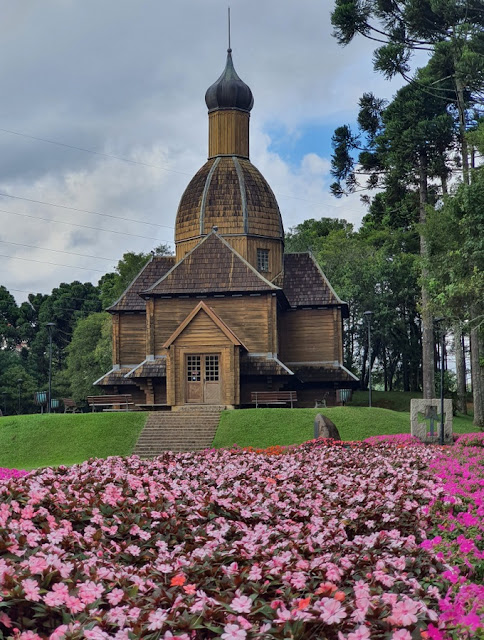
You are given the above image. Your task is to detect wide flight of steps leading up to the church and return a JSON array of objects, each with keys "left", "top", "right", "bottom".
[{"left": 133, "top": 405, "right": 225, "bottom": 458}]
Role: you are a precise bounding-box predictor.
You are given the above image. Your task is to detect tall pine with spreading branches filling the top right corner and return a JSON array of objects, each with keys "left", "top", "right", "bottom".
[{"left": 331, "top": 0, "right": 484, "bottom": 405}]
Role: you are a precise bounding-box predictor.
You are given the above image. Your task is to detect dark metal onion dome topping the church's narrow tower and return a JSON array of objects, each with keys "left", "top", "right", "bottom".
[{"left": 205, "top": 49, "right": 254, "bottom": 113}]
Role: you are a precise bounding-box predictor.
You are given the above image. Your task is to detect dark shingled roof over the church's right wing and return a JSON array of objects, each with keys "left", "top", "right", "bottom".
[{"left": 283, "top": 253, "right": 347, "bottom": 308}]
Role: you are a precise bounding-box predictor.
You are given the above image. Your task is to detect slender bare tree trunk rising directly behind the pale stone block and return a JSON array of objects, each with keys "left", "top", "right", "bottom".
[{"left": 419, "top": 153, "right": 435, "bottom": 399}]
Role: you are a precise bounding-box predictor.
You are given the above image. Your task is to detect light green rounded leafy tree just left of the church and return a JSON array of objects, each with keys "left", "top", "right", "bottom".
[{"left": 65, "top": 312, "right": 112, "bottom": 402}]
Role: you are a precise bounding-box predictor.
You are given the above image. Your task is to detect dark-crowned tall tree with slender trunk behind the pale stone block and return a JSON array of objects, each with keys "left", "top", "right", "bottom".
[{"left": 332, "top": 70, "right": 453, "bottom": 398}]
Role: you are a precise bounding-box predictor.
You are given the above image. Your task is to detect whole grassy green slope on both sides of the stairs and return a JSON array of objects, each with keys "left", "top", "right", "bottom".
[{"left": 0, "top": 407, "right": 476, "bottom": 469}]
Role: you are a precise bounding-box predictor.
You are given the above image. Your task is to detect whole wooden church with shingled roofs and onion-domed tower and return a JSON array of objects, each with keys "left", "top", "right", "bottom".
[{"left": 94, "top": 49, "right": 357, "bottom": 408}]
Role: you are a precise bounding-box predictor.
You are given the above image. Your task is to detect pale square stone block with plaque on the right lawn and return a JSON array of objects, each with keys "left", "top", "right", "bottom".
[{"left": 410, "top": 398, "right": 454, "bottom": 444}]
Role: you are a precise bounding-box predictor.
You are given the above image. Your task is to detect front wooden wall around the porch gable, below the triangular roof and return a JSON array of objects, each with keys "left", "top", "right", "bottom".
[{"left": 153, "top": 294, "right": 275, "bottom": 355}]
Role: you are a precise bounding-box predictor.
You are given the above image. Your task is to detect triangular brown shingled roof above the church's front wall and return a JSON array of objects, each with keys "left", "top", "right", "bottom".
[{"left": 143, "top": 231, "right": 279, "bottom": 295}]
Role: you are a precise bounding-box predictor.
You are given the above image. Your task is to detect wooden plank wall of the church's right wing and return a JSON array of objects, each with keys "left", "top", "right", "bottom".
[{"left": 279, "top": 309, "right": 343, "bottom": 366}]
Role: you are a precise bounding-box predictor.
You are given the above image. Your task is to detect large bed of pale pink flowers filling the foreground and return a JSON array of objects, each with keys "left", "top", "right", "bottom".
[{"left": 0, "top": 441, "right": 482, "bottom": 640}]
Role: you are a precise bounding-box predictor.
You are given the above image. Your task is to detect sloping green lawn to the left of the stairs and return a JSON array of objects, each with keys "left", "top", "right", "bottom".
[{"left": 0, "top": 411, "right": 148, "bottom": 470}]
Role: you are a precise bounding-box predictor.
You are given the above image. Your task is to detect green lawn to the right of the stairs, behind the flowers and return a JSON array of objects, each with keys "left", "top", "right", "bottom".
[{"left": 213, "top": 407, "right": 476, "bottom": 448}]
